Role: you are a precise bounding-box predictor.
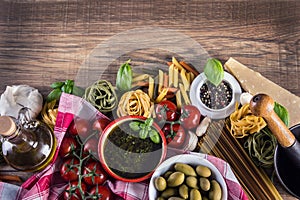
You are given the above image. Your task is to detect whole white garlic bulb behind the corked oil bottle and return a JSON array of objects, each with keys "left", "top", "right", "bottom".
[{"left": 0, "top": 85, "right": 43, "bottom": 118}]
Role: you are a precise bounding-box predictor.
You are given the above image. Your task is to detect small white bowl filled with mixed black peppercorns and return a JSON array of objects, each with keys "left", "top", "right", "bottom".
[{"left": 190, "top": 72, "right": 242, "bottom": 119}]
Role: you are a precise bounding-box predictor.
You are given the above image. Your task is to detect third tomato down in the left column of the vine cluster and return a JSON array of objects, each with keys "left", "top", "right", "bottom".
[{"left": 60, "top": 158, "right": 79, "bottom": 181}]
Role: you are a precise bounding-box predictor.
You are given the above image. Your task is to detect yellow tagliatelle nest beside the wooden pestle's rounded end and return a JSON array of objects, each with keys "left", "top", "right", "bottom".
[{"left": 230, "top": 104, "right": 267, "bottom": 138}]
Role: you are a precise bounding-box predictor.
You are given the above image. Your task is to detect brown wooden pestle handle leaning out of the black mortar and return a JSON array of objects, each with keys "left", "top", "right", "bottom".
[{"left": 250, "top": 94, "right": 296, "bottom": 147}]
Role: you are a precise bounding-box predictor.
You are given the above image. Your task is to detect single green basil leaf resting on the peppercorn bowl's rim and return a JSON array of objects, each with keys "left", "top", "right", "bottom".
[{"left": 204, "top": 58, "right": 224, "bottom": 86}]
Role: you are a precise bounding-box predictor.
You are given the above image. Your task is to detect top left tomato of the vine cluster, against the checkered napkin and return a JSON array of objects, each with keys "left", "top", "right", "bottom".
[{"left": 68, "top": 118, "right": 91, "bottom": 138}]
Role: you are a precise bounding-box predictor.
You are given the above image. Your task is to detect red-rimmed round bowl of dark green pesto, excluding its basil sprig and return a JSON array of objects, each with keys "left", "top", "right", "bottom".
[{"left": 98, "top": 116, "right": 167, "bottom": 182}]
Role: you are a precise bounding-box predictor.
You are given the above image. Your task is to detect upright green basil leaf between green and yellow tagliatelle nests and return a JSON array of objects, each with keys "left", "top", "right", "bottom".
[{"left": 116, "top": 60, "right": 132, "bottom": 92}]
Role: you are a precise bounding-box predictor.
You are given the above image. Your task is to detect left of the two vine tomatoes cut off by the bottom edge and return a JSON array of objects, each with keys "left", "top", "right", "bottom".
[{"left": 64, "top": 181, "right": 87, "bottom": 200}]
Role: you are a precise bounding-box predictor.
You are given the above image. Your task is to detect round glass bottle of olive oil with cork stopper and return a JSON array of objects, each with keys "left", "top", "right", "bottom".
[{"left": 0, "top": 109, "right": 56, "bottom": 171}]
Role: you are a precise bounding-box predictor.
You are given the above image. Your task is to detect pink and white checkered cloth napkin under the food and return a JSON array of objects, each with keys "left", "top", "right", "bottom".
[{"left": 0, "top": 93, "right": 247, "bottom": 200}]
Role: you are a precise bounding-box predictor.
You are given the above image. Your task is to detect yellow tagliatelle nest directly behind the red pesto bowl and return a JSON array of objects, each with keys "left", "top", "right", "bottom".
[{"left": 117, "top": 90, "right": 152, "bottom": 117}]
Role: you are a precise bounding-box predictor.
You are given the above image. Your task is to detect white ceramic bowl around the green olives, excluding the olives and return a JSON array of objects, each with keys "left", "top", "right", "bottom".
[{"left": 149, "top": 154, "right": 228, "bottom": 200}]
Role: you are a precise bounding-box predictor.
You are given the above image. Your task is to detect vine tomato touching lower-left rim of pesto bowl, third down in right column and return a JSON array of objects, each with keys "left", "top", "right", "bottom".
[{"left": 83, "top": 161, "right": 107, "bottom": 185}]
